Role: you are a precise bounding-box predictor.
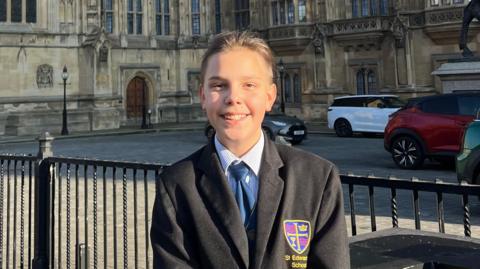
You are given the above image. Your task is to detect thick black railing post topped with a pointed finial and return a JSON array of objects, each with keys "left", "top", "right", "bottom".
[{"left": 33, "top": 132, "right": 53, "bottom": 269}]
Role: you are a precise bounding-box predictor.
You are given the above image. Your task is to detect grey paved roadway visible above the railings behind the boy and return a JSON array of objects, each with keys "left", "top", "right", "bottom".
[{"left": 0, "top": 131, "right": 456, "bottom": 182}]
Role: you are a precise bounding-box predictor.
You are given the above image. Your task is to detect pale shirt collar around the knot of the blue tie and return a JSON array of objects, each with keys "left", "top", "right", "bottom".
[{"left": 214, "top": 132, "right": 265, "bottom": 176}]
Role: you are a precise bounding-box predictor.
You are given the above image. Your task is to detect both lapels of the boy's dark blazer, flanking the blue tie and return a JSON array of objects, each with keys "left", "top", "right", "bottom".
[{"left": 198, "top": 139, "right": 284, "bottom": 268}]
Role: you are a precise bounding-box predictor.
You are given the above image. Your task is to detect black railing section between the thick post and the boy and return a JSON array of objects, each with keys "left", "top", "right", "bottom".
[{"left": 39, "top": 157, "right": 163, "bottom": 268}]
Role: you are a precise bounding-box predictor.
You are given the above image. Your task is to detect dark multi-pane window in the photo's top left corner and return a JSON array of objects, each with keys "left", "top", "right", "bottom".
[{"left": 0, "top": 0, "right": 37, "bottom": 23}]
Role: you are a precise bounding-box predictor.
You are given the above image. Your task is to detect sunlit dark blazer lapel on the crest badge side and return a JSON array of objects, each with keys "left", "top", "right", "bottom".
[{"left": 255, "top": 139, "right": 284, "bottom": 268}]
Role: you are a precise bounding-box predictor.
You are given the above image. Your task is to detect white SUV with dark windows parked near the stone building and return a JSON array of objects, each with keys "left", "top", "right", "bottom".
[{"left": 327, "top": 95, "right": 405, "bottom": 137}]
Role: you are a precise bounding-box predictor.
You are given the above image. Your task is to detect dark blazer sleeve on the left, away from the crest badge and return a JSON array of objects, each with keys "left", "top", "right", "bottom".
[{"left": 150, "top": 175, "right": 200, "bottom": 269}]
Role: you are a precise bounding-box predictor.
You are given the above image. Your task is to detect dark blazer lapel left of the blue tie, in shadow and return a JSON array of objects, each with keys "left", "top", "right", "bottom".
[{"left": 199, "top": 142, "right": 249, "bottom": 268}]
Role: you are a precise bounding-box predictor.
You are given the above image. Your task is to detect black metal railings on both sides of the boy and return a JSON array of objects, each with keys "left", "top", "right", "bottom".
[{"left": 0, "top": 133, "right": 480, "bottom": 268}]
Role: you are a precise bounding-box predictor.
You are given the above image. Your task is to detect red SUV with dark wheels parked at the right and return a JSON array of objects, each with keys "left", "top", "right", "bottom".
[{"left": 384, "top": 91, "right": 480, "bottom": 169}]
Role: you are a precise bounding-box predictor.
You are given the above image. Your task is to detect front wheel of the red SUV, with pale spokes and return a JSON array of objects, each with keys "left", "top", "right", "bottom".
[{"left": 392, "top": 136, "right": 425, "bottom": 169}]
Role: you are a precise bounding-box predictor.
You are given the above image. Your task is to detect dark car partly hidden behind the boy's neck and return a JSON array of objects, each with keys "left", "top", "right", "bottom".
[{"left": 205, "top": 113, "right": 307, "bottom": 145}]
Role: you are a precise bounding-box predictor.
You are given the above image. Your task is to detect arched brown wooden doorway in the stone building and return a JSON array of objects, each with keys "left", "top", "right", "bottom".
[{"left": 126, "top": 76, "right": 148, "bottom": 122}]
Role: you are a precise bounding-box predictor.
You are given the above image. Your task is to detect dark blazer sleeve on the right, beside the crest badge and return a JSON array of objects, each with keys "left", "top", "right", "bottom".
[{"left": 308, "top": 165, "right": 350, "bottom": 269}]
